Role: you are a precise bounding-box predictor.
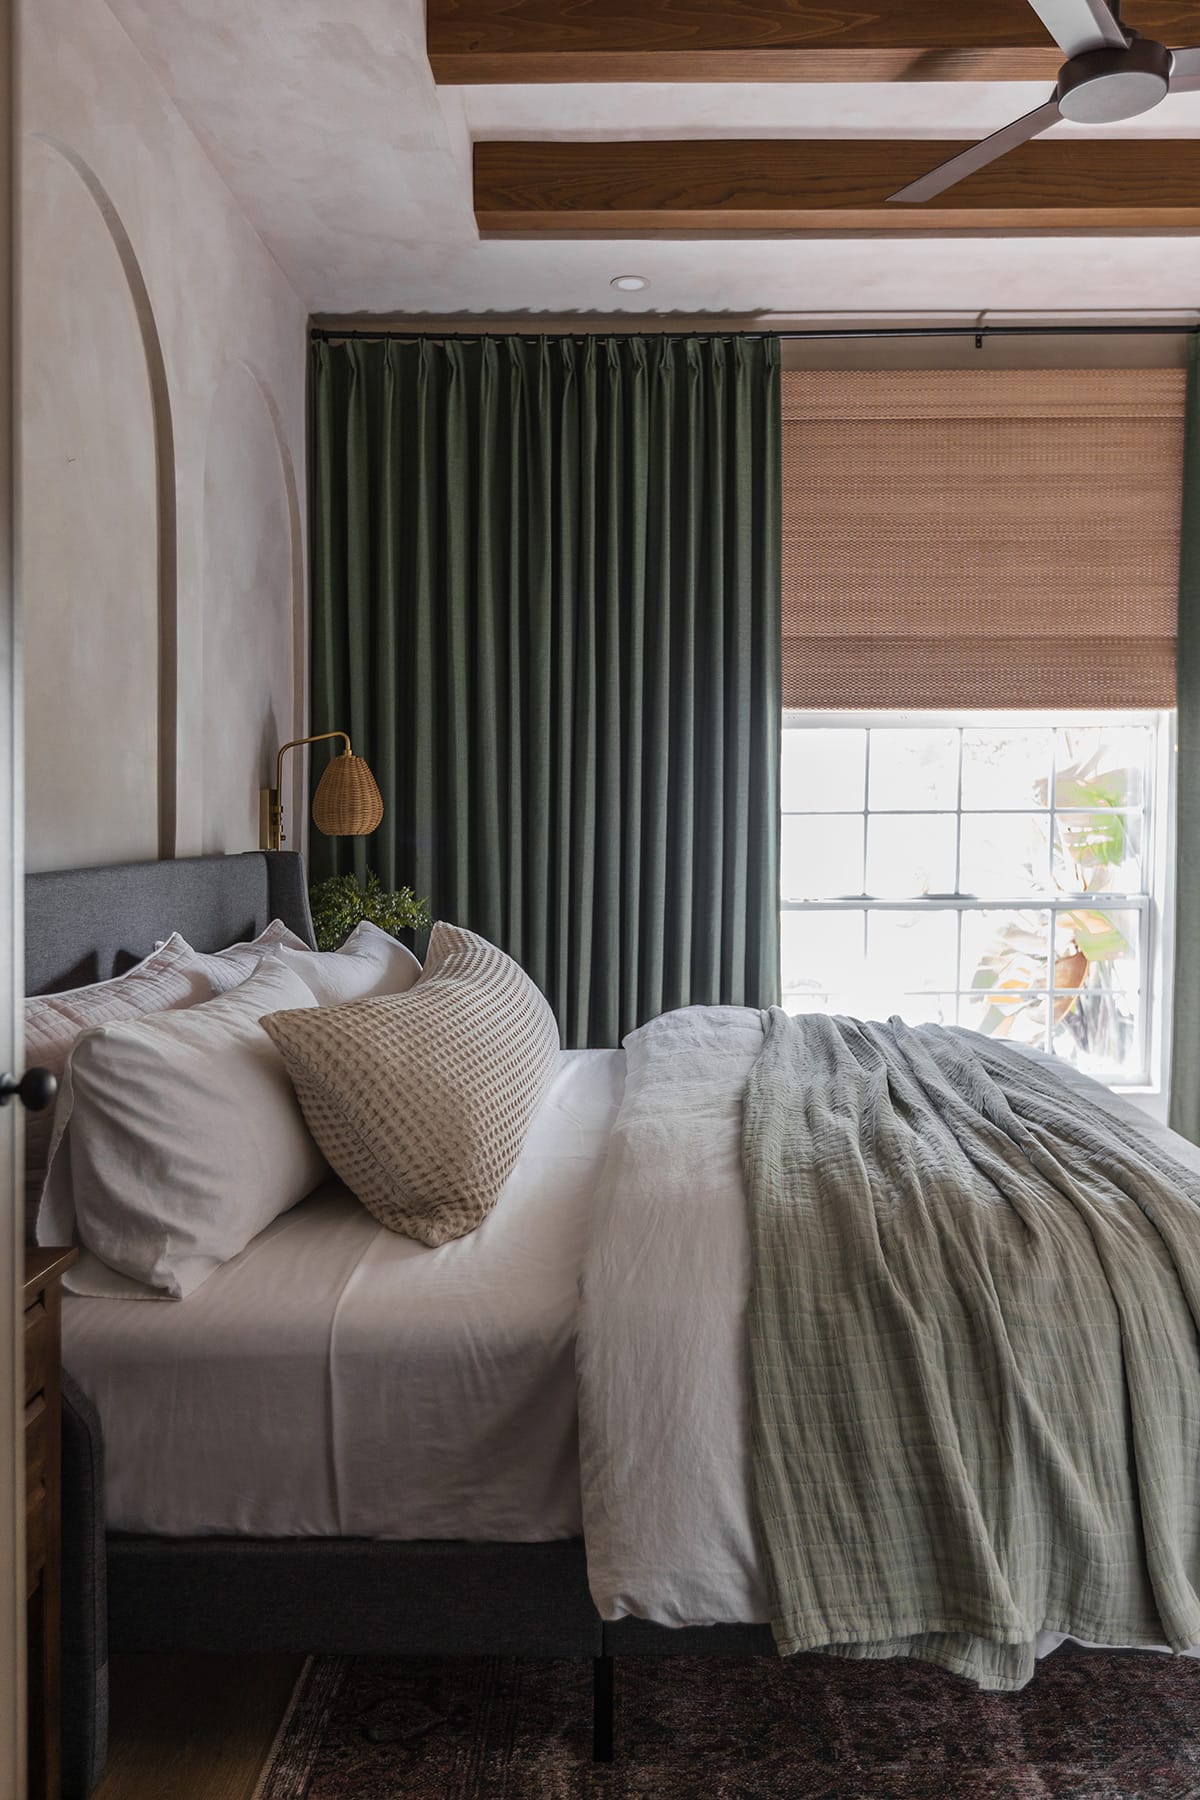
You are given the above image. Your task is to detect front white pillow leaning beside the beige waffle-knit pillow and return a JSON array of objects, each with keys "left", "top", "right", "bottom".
[{"left": 38, "top": 958, "right": 327, "bottom": 1300}]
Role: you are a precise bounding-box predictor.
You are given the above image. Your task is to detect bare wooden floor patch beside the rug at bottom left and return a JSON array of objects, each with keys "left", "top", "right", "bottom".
[{"left": 94, "top": 1656, "right": 300, "bottom": 1800}]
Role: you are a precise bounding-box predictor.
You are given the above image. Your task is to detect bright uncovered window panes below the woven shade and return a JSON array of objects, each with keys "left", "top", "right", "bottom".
[{"left": 781, "top": 711, "right": 1173, "bottom": 1087}]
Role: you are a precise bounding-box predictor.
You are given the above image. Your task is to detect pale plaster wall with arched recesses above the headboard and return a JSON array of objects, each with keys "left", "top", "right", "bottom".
[{"left": 18, "top": 0, "right": 306, "bottom": 869}]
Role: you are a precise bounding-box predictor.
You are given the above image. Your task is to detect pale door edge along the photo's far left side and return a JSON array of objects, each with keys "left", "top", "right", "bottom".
[{"left": 0, "top": 0, "right": 25, "bottom": 1800}]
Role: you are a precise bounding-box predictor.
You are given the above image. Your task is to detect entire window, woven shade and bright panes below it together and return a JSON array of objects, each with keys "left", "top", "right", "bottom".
[{"left": 781, "top": 358, "right": 1186, "bottom": 1111}]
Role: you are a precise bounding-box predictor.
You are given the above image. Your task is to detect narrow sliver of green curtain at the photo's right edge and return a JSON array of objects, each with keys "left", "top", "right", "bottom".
[{"left": 1169, "top": 335, "right": 1200, "bottom": 1143}]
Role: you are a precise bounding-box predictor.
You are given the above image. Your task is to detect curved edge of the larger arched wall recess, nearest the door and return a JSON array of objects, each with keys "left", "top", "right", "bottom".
[{"left": 36, "top": 131, "right": 178, "bottom": 860}]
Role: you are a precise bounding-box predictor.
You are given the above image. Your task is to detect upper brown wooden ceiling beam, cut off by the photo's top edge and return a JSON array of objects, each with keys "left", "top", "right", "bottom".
[{"left": 426, "top": 0, "right": 1200, "bottom": 83}]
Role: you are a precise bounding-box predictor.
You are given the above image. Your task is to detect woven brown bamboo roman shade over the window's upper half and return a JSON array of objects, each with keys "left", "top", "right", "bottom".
[{"left": 783, "top": 369, "right": 1184, "bottom": 709}]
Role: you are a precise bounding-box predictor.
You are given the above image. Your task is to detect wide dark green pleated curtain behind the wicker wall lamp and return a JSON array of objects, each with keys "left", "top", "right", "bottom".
[{"left": 311, "top": 337, "right": 781, "bottom": 1046}]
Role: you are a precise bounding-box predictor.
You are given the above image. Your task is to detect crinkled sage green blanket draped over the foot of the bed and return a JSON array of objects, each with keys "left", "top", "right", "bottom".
[{"left": 743, "top": 1010, "right": 1200, "bottom": 1688}]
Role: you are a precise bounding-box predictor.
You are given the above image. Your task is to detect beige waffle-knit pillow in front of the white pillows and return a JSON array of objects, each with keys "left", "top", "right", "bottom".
[{"left": 263, "top": 925, "right": 558, "bottom": 1244}]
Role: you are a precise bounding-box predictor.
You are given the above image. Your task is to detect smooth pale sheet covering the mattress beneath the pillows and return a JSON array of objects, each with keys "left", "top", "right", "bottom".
[{"left": 63, "top": 1051, "right": 624, "bottom": 1543}]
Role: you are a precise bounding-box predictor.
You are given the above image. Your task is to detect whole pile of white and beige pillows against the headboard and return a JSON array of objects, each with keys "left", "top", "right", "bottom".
[{"left": 25, "top": 922, "right": 560, "bottom": 1300}]
